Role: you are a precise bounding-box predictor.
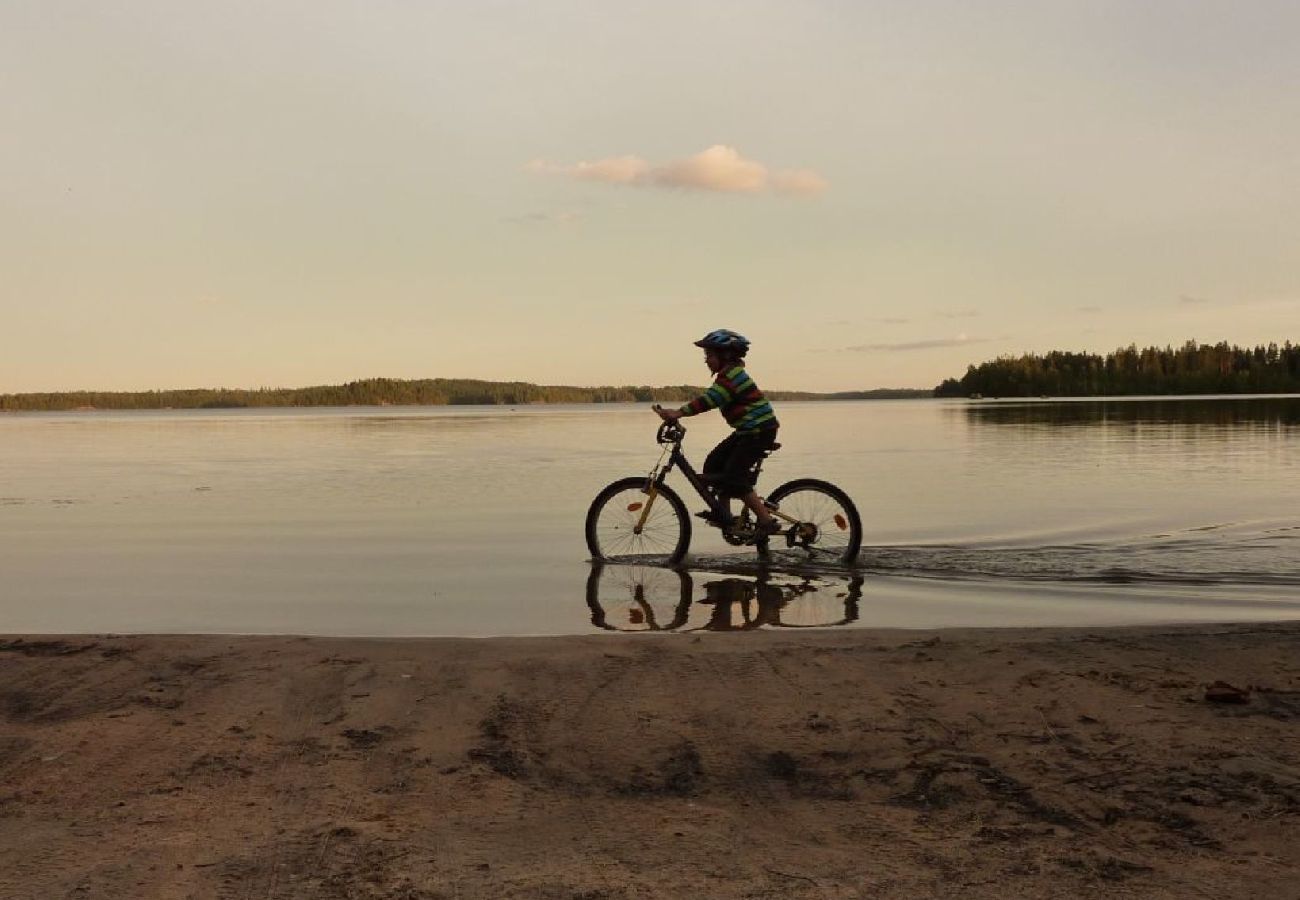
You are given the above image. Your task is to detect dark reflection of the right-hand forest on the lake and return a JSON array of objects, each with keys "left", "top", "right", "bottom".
[{"left": 959, "top": 397, "right": 1300, "bottom": 427}]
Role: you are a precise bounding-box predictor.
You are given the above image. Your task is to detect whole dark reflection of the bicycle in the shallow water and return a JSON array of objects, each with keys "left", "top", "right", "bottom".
[{"left": 586, "top": 563, "right": 863, "bottom": 631}]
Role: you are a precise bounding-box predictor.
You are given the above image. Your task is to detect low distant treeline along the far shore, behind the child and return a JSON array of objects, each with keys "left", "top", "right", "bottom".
[{"left": 0, "top": 378, "right": 931, "bottom": 411}]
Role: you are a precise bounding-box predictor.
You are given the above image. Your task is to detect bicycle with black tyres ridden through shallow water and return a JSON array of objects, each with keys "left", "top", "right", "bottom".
[{"left": 585, "top": 413, "right": 862, "bottom": 563}]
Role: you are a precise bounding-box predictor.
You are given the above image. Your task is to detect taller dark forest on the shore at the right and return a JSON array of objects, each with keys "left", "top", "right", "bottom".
[{"left": 935, "top": 341, "right": 1300, "bottom": 397}]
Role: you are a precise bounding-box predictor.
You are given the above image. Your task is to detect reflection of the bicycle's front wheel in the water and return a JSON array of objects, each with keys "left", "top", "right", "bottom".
[{"left": 586, "top": 562, "right": 693, "bottom": 631}]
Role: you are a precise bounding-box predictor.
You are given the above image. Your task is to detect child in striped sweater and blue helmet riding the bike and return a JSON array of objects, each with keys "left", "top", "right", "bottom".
[{"left": 657, "top": 328, "right": 780, "bottom": 535}]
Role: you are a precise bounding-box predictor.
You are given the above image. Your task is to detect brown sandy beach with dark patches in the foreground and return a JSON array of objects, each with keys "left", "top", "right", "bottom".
[{"left": 0, "top": 623, "right": 1300, "bottom": 900}]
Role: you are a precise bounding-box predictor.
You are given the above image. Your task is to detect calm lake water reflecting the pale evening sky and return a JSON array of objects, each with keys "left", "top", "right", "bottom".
[{"left": 0, "top": 398, "right": 1300, "bottom": 636}]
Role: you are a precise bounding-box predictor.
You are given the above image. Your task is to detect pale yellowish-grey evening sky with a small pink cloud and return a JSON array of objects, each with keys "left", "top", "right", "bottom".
[{"left": 0, "top": 0, "right": 1300, "bottom": 393}]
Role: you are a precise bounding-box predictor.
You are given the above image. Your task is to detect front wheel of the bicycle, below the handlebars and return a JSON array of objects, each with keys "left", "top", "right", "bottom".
[{"left": 586, "top": 476, "right": 690, "bottom": 563}]
